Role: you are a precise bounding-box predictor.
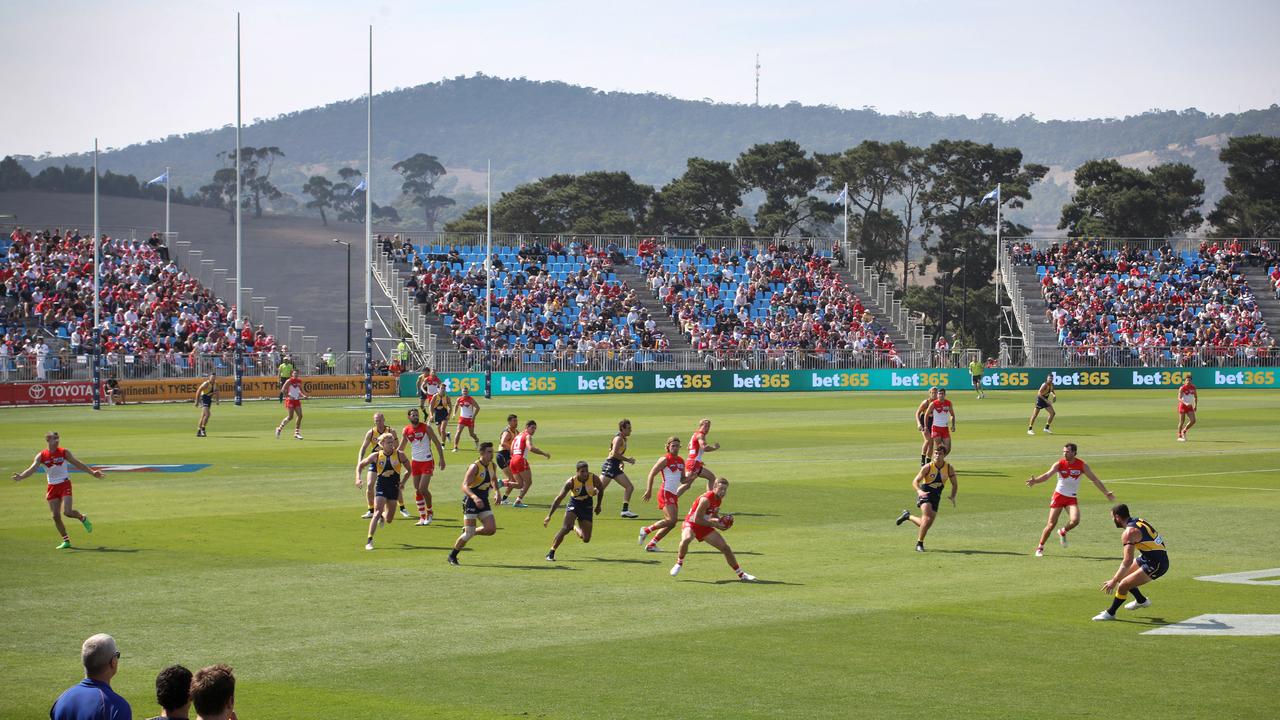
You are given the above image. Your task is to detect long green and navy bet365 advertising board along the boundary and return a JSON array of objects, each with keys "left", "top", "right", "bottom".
[{"left": 399, "top": 368, "right": 1280, "bottom": 397}]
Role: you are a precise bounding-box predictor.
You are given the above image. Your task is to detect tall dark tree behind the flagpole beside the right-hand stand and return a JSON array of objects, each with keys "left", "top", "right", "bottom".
[{"left": 911, "top": 140, "right": 1048, "bottom": 354}]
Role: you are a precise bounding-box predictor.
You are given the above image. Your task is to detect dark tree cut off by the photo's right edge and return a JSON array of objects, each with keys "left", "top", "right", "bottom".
[{"left": 1208, "top": 135, "right": 1280, "bottom": 237}]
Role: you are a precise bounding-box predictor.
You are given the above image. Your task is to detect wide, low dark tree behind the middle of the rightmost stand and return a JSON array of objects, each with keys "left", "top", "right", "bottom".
[{"left": 1057, "top": 160, "right": 1204, "bottom": 237}]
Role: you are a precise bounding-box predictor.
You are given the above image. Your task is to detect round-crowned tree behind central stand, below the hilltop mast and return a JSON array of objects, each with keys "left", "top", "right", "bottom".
[{"left": 733, "top": 140, "right": 835, "bottom": 237}]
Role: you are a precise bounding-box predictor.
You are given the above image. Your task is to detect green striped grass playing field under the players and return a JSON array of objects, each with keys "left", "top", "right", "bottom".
[{"left": 0, "top": 391, "right": 1280, "bottom": 719}]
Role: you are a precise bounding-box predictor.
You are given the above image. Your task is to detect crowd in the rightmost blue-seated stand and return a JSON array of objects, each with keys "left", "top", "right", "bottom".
[{"left": 1034, "top": 240, "right": 1275, "bottom": 365}]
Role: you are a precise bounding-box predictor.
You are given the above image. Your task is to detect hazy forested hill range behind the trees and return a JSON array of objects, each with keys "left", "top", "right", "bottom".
[{"left": 10, "top": 74, "right": 1280, "bottom": 225}]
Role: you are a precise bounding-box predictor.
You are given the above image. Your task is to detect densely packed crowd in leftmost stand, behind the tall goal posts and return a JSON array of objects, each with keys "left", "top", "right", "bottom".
[{"left": 0, "top": 228, "right": 282, "bottom": 379}]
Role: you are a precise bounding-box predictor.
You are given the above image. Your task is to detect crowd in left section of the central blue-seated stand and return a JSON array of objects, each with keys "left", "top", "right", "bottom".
[{"left": 392, "top": 238, "right": 669, "bottom": 369}]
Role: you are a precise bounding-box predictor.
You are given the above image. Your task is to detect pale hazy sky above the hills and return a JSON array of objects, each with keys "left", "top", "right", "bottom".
[{"left": 0, "top": 0, "right": 1280, "bottom": 155}]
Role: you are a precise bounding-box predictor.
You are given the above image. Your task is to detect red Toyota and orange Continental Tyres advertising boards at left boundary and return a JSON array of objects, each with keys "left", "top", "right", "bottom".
[{"left": 0, "top": 375, "right": 396, "bottom": 406}]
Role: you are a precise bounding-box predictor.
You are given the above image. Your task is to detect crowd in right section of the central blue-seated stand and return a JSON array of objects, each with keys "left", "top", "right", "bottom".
[{"left": 639, "top": 241, "right": 902, "bottom": 366}]
